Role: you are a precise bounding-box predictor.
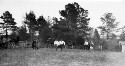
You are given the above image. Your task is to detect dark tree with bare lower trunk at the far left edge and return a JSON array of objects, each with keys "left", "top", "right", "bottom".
[{"left": 0, "top": 11, "right": 16, "bottom": 38}]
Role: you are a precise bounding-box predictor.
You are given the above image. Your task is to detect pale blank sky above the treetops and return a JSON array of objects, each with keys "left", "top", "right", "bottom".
[{"left": 0, "top": 0, "right": 125, "bottom": 28}]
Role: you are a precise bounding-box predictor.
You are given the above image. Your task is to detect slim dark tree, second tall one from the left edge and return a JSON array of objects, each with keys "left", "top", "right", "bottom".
[{"left": 24, "top": 11, "right": 38, "bottom": 40}]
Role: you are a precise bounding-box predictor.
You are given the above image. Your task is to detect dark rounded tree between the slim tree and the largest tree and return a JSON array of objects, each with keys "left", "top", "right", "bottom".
[{"left": 37, "top": 16, "right": 51, "bottom": 43}]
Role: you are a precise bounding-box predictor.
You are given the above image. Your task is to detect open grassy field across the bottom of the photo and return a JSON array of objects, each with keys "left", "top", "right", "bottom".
[{"left": 0, "top": 48, "right": 125, "bottom": 66}]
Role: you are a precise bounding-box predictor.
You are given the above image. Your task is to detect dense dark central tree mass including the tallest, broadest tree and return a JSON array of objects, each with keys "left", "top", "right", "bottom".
[{"left": 20, "top": 2, "right": 91, "bottom": 46}]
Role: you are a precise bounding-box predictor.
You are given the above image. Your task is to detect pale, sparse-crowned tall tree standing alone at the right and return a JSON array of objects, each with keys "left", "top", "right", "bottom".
[{"left": 98, "top": 13, "right": 118, "bottom": 39}]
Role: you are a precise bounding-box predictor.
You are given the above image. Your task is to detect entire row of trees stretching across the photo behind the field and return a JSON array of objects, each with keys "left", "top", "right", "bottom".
[{"left": 0, "top": 2, "right": 125, "bottom": 49}]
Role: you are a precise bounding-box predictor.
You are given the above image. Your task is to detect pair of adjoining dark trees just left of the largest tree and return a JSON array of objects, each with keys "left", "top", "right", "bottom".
[{"left": 24, "top": 11, "right": 51, "bottom": 42}]
